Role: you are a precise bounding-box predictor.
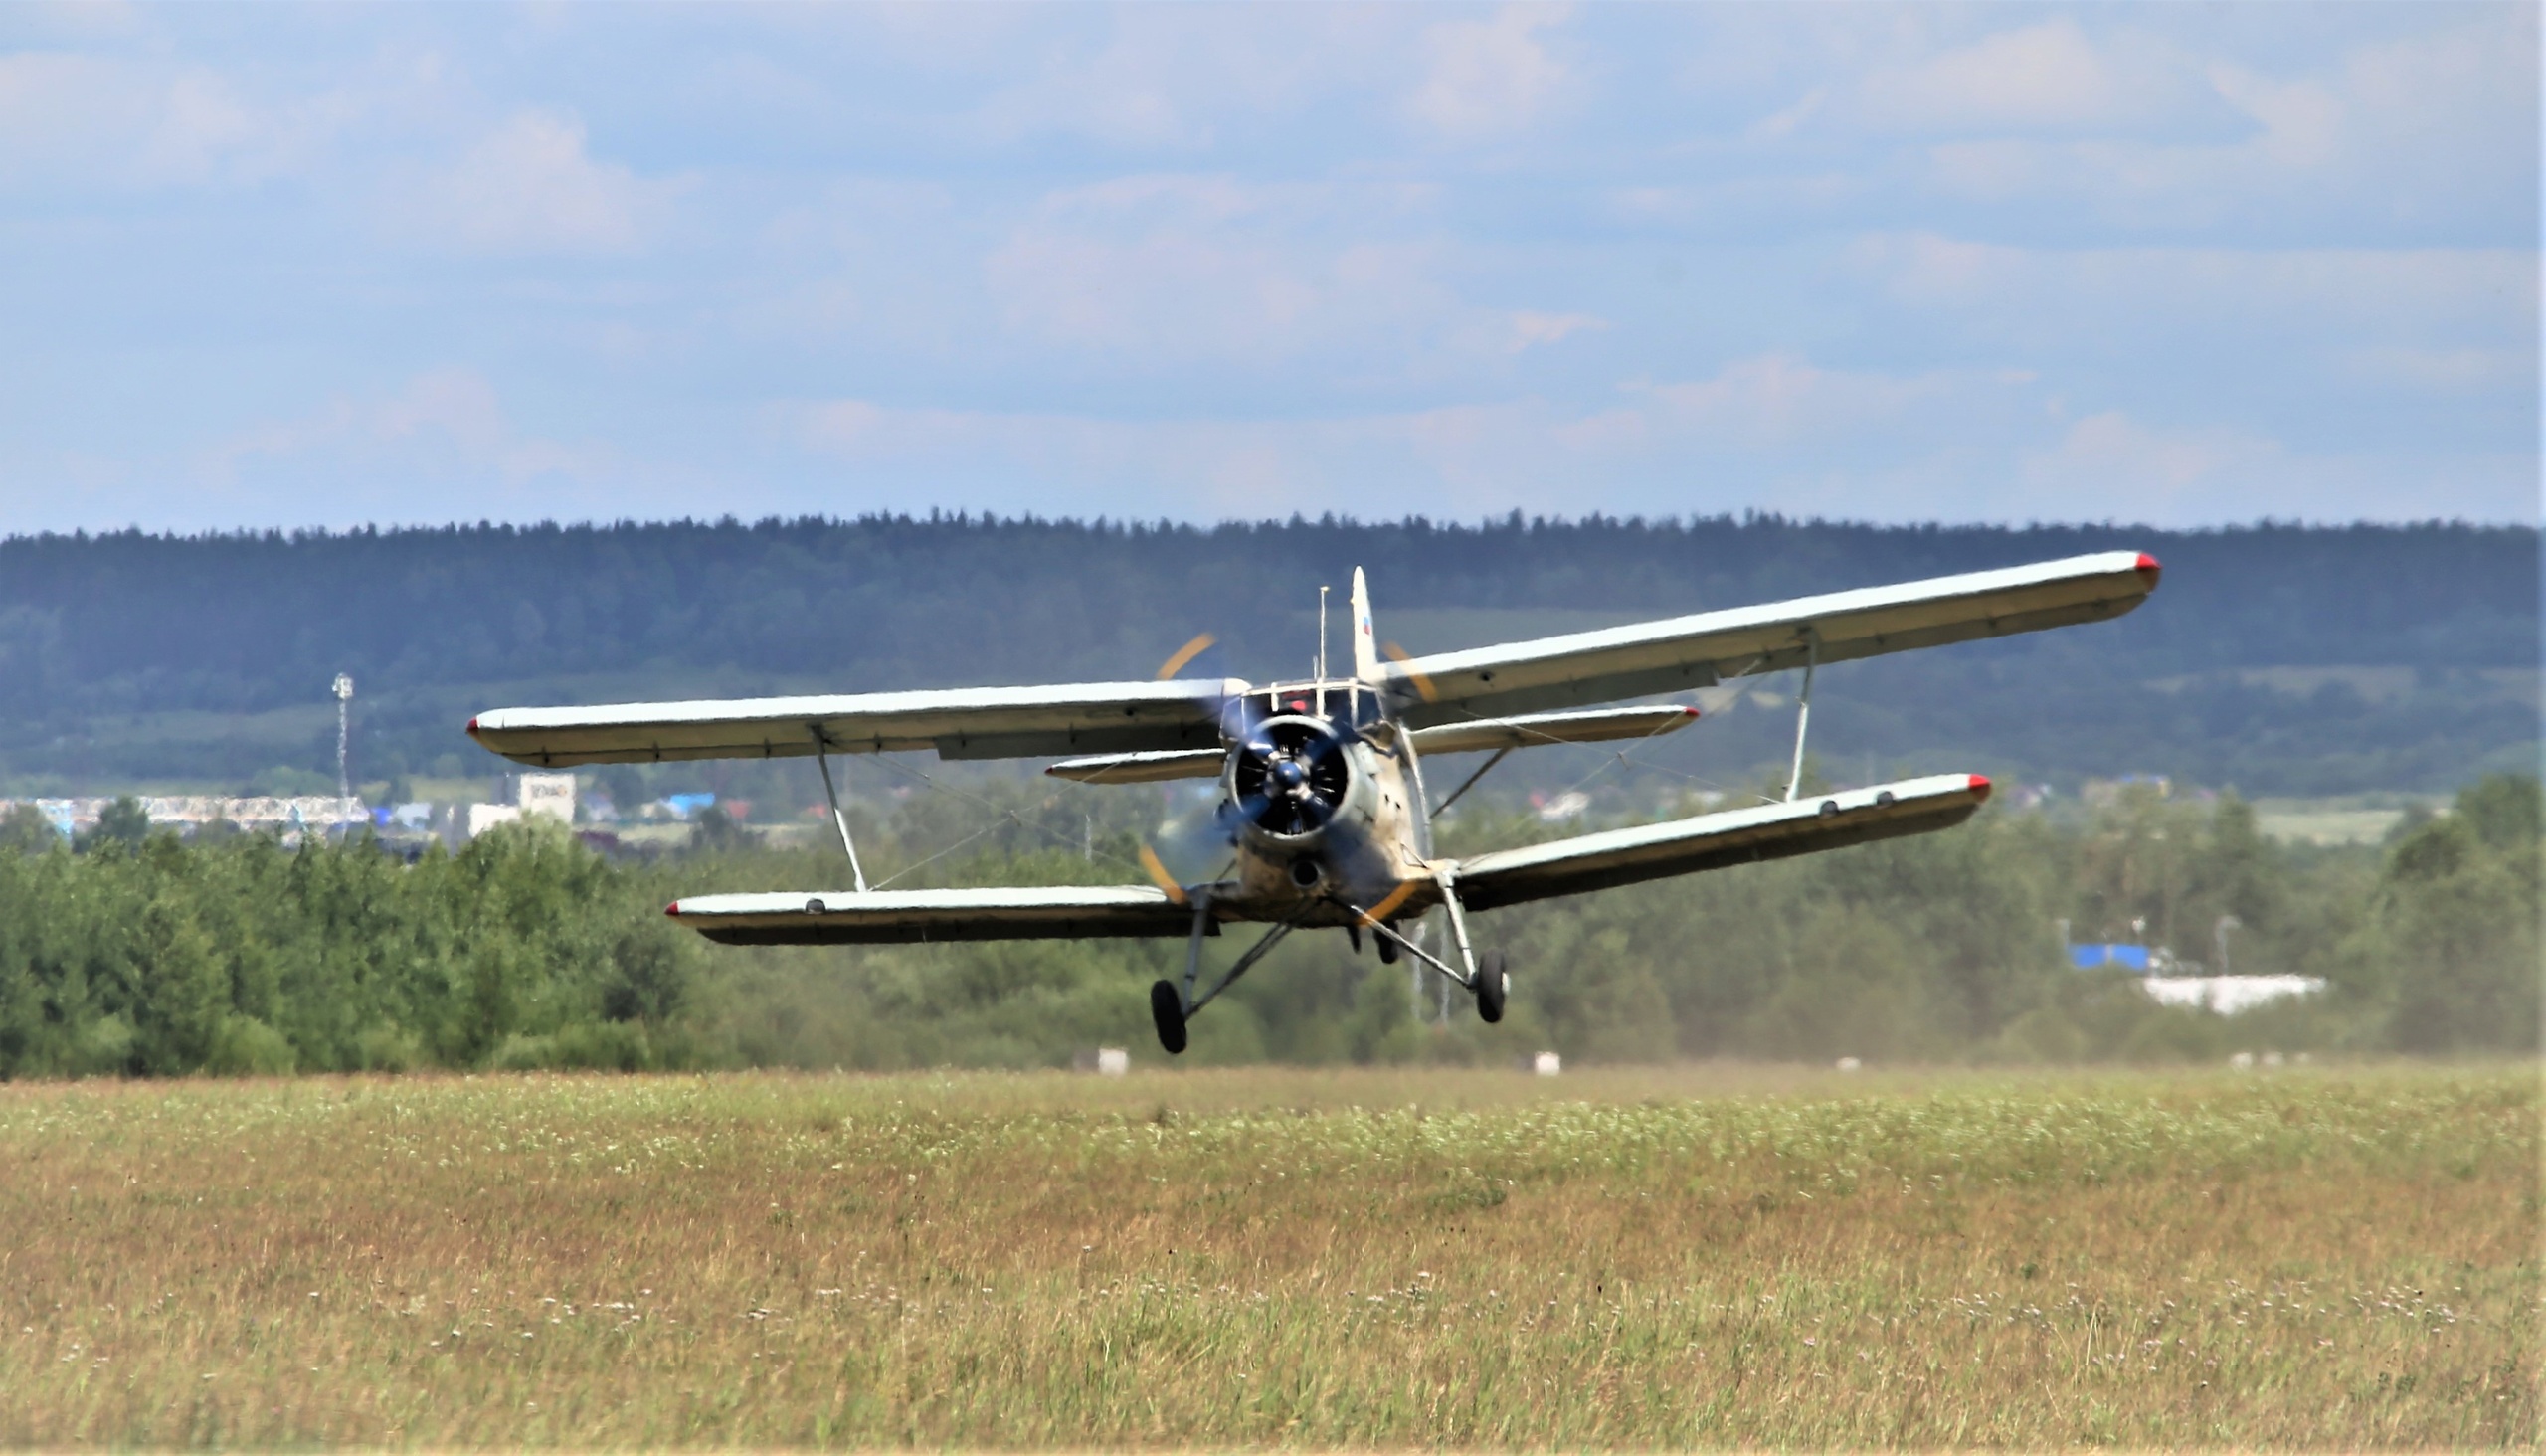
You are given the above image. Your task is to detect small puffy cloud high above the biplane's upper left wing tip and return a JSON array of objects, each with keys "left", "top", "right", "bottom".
[{"left": 397, "top": 109, "right": 677, "bottom": 252}]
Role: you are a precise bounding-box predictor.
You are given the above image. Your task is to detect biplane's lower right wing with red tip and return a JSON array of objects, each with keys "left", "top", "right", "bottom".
[{"left": 1459, "top": 774, "right": 1988, "bottom": 909}]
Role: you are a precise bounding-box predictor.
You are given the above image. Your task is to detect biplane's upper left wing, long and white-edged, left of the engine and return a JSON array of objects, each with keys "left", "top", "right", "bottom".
[{"left": 468, "top": 679, "right": 1247, "bottom": 766}]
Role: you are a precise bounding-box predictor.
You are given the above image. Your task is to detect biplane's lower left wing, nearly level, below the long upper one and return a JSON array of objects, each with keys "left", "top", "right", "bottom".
[{"left": 664, "top": 886, "right": 1219, "bottom": 945}]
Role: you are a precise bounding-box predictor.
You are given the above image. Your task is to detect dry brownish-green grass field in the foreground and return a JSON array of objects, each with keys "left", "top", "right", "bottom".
[{"left": 0, "top": 1066, "right": 2541, "bottom": 1448}]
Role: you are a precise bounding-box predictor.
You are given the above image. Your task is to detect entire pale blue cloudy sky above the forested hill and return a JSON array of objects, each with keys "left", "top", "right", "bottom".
[{"left": 0, "top": 3, "right": 2541, "bottom": 534}]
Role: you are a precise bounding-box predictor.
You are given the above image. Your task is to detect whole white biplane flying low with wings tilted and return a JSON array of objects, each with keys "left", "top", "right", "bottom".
[{"left": 468, "top": 552, "right": 2159, "bottom": 1054}]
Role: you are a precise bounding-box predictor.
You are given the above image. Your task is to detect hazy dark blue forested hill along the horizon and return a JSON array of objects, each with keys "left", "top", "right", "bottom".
[{"left": 0, "top": 517, "right": 2538, "bottom": 792}]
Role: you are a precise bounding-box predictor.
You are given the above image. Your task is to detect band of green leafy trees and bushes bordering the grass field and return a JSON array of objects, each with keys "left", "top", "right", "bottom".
[{"left": 0, "top": 777, "right": 2541, "bottom": 1077}]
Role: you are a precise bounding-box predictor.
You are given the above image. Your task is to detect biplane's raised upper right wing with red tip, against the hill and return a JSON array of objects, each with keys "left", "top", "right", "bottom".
[{"left": 1382, "top": 550, "right": 2156, "bottom": 728}]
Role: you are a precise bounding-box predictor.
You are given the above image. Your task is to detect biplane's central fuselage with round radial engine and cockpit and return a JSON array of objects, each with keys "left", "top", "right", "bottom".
[{"left": 1212, "top": 679, "right": 1436, "bottom": 927}]
